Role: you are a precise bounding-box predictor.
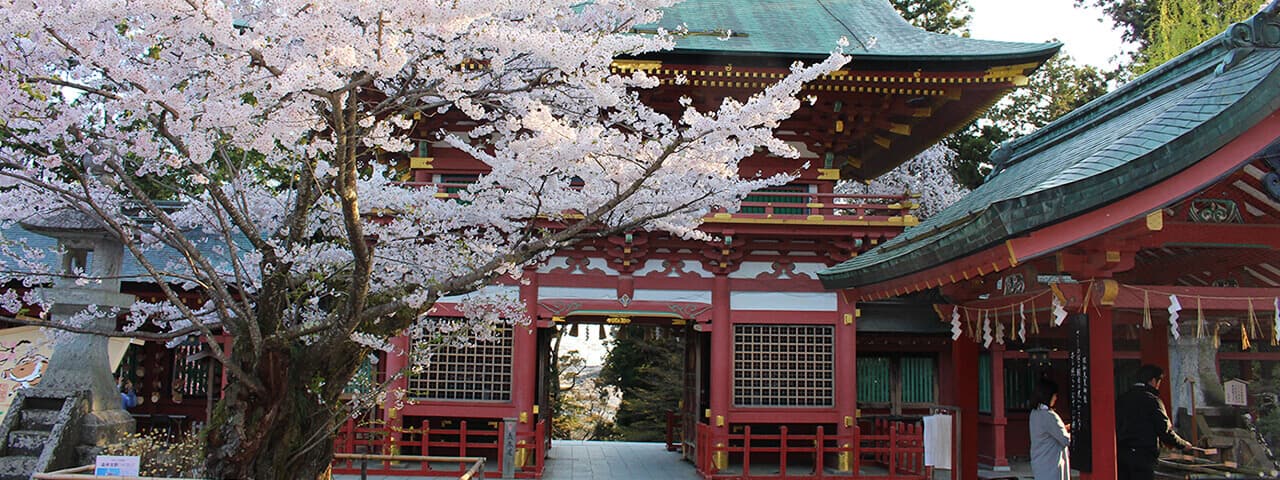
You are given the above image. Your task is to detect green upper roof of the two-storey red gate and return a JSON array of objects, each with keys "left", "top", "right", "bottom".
[{"left": 649, "top": 0, "right": 1061, "bottom": 61}]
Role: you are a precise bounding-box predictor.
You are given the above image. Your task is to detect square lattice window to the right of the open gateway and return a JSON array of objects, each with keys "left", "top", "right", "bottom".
[{"left": 733, "top": 325, "right": 836, "bottom": 407}]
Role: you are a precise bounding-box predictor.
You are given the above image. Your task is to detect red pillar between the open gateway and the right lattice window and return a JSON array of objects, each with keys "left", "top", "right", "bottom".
[{"left": 699, "top": 273, "right": 733, "bottom": 471}]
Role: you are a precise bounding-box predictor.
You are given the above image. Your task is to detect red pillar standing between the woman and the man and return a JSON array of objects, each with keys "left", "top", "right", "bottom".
[{"left": 1082, "top": 306, "right": 1116, "bottom": 480}]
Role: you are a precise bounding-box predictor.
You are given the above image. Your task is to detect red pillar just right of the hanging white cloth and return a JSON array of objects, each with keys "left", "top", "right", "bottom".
[{"left": 951, "top": 337, "right": 978, "bottom": 479}]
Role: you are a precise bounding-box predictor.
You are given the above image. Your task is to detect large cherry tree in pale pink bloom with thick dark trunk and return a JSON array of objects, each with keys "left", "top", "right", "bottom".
[{"left": 0, "top": 0, "right": 847, "bottom": 479}]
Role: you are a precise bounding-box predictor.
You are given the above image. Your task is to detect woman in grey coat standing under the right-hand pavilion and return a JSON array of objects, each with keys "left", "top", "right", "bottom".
[{"left": 1029, "top": 379, "right": 1071, "bottom": 480}]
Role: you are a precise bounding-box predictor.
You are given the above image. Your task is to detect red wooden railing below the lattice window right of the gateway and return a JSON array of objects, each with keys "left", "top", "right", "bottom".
[{"left": 695, "top": 422, "right": 933, "bottom": 480}]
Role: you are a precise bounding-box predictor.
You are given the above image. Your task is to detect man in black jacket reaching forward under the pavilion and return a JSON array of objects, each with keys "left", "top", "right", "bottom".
[{"left": 1116, "top": 364, "right": 1204, "bottom": 480}]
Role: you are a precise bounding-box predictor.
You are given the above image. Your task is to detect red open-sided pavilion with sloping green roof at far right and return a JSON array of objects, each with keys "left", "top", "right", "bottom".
[{"left": 819, "top": 3, "right": 1280, "bottom": 479}]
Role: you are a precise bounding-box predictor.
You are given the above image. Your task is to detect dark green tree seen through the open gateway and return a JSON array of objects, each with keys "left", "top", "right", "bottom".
[{"left": 600, "top": 326, "right": 685, "bottom": 442}]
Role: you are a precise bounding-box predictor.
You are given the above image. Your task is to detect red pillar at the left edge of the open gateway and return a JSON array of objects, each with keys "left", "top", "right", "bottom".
[{"left": 511, "top": 268, "right": 538, "bottom": 431}]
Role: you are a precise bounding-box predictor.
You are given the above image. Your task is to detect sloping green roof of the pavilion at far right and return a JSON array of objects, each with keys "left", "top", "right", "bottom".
[{"left": 818, "top": 0, "right": 1280, "bottom": 288}]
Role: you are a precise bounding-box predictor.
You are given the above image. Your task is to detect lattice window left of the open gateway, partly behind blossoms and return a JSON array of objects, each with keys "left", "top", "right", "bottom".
[{"left": 408, "top": 329, "right": 512, "bottom": 402}]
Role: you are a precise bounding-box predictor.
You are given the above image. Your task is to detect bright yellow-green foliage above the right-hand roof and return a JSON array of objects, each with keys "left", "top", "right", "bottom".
[{"left": 1130, "top": 0, "right": 1262, "bottom": 76}]
